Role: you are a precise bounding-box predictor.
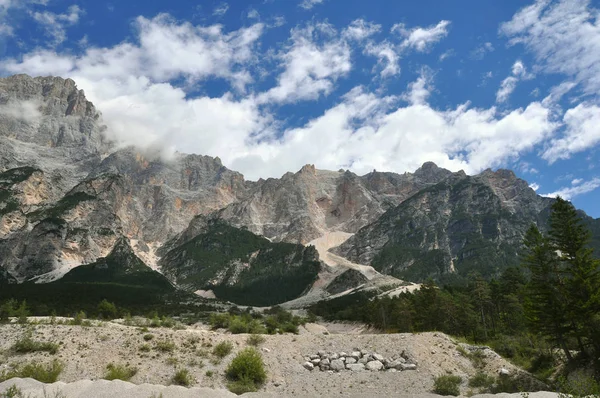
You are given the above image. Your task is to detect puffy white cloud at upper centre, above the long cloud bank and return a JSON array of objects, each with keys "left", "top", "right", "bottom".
[{"left": 258, "top": 23, "right": 352, "bottom": 103}]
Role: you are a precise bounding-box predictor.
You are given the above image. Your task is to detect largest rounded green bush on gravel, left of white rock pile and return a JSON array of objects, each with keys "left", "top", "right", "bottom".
[{"left": 225, "top": 347, "right": 267, "bottom": 394}]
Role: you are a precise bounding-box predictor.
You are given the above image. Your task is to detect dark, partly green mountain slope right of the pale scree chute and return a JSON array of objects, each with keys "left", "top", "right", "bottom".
[{"left": 336, "top": 170, "right": 564, "bottom": 280}]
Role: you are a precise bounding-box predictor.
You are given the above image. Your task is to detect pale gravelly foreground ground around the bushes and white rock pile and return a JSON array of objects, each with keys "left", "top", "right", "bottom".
[{"left": 0, "top": 322, "right": 548, "bottom": 397}]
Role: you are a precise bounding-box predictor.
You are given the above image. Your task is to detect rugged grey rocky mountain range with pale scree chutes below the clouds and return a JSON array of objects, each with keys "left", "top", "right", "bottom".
[{"left": 0, "top": 75, "right": 600, "bottom": 306}]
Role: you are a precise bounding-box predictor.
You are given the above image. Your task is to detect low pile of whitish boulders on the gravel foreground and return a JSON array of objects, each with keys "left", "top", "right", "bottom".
[{"left": 302, "top": 349, "right": 417, "bottom": 372}]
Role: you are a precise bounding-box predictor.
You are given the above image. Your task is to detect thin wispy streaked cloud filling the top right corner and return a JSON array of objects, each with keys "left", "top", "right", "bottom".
[{"left": 500, "top": 0, "right": 600, "bottom": 95}]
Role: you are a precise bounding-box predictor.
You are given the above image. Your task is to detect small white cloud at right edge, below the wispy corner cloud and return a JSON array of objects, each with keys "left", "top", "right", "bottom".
[{"left": 542, "top": 103, "right": 600, "bottom": 164}]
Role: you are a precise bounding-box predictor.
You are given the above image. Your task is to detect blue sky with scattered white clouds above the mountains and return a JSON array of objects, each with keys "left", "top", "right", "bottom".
[{"left": 0, "top": 0, "right": 600, "bottom": 217}]
